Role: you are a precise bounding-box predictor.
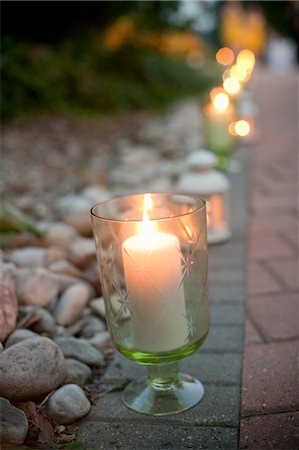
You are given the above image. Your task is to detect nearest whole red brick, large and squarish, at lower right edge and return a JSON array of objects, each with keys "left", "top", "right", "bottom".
[{"left": 242, "top": 341, "right": 299, "bottom": 415}]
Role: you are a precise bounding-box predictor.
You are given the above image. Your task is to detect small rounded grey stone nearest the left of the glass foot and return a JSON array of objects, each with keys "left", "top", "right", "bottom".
[{"left": 47, "top": 384, "right": 91, "bottom": 425}]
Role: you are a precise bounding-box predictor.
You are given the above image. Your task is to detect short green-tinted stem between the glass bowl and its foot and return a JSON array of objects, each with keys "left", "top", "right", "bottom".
[{"left": 147, "top": 363, "right": 180, "bottom": 391}]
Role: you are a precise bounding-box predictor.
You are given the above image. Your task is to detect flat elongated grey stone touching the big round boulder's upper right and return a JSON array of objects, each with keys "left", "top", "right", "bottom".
[{"left": 55, "top": 337, "right": 104, "bottom": 367}]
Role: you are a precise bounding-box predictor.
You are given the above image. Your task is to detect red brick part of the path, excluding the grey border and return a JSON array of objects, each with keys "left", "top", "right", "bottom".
[{"left": 240, "top": 71, "right": 299, "bottom": 450}]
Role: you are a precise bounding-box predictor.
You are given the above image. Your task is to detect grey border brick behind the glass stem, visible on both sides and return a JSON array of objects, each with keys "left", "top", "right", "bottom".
[{"left": 104, "top": 349, "right": 242, "bottom": 384}]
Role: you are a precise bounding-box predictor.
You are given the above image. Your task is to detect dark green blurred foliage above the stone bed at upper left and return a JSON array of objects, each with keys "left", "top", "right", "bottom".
[{"left": 1, "top": 31, "right": 219, "bottom": 121}]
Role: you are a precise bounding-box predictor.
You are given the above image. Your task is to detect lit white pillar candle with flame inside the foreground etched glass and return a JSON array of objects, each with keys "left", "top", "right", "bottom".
[{"left": 122, "top": 194, "right": 188, "bottom": 352}]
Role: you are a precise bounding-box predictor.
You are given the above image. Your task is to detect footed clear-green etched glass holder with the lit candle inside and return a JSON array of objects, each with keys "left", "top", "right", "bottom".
[{"left": 91, "top": 193, "right": 209, "bottom": 416}]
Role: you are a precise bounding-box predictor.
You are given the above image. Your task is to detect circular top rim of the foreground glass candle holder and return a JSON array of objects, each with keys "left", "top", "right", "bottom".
[{"left": 90, "top": 192, "right": 206, "bottom": 223}]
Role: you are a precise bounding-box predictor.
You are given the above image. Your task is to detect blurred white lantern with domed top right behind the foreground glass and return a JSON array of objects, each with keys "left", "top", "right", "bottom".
[{"left": 177, "top": 150, "right": 231, "bottom": 244}]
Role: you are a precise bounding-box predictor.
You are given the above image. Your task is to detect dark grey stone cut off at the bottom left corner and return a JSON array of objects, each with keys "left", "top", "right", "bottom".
[{"left": 0, "top": 397, "right": 29, "bottom": 446}]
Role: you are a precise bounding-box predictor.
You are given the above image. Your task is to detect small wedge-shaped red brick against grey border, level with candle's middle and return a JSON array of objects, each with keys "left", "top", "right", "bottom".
[{"left": 247, "top": 262, "right": 282, "bottom": 296}]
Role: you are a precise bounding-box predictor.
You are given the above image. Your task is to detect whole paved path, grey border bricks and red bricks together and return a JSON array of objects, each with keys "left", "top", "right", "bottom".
[{"left": 73, "top": 71, "right": 299, "bottom": 450}]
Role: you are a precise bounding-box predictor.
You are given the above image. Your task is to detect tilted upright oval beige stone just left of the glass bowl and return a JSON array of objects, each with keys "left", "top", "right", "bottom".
[{"left": 55, "top": 283, "right": 90, "bottom": 326}]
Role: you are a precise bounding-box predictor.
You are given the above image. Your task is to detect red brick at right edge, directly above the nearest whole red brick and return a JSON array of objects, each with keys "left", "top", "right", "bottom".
[{"left": 247, "top": 293, "right": 299, "bottom": 342}]
